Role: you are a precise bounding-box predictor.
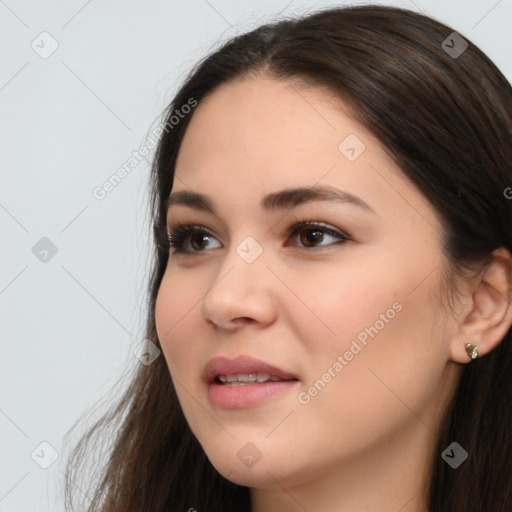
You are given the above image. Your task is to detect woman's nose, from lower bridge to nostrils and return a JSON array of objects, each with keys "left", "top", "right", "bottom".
[{"left": 201, "top": 241, "right": 278, "bottom": 331}]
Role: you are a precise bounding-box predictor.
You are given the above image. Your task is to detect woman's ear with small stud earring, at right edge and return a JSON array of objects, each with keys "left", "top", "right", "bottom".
[{"left": 450, "top": 247, "right": 512, "bottom": 364}]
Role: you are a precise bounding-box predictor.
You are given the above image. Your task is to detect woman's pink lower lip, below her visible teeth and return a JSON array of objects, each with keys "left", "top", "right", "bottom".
[{"left": 208, "top": 380, "right": 299, "bottom": 409}]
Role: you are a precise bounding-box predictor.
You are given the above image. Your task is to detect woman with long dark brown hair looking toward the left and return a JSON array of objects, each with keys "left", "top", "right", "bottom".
[{"left": 64, "top": 6, "right": 512, "bottom": 512}]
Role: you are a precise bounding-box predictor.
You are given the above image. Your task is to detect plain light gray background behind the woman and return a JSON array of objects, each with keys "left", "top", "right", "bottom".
[{"left": 0, "top": 0, "right": 512, "bottom": 512}]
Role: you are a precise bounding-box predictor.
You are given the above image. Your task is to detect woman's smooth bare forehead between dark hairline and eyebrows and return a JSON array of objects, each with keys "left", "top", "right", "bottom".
[{"left": 173, "top": 77, "right": 436, "bottom": 232}]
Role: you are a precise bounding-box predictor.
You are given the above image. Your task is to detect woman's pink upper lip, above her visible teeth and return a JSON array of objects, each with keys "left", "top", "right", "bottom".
[{"left": 203, "top": 356, "right": 298, "bottom": 384}]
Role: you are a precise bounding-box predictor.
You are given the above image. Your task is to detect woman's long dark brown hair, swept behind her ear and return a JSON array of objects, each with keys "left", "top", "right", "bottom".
[{"left": 66, "top": 5, "right": 512, "bottom": 512}]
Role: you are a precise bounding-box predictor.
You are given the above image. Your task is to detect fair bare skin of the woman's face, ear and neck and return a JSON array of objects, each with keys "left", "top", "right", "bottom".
[{"left": 155, "top": 76, "right": 512, "bottom": 512}]
